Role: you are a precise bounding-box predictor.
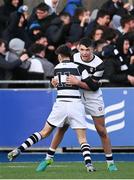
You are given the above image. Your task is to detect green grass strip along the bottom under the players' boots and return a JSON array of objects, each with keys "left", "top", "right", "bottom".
[{"left": 0, "top": 162, "right": 134, "bottom": 179}]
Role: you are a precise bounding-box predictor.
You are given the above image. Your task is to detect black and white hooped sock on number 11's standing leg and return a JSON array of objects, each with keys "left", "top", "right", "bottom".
[{"left": 81, "top": 143, "right": 92, "bottom": 165}]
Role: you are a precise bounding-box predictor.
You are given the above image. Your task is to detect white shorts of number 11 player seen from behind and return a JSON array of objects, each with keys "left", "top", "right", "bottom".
[{"left": 47, "top": 101, "right": 87, "bottom": 129}]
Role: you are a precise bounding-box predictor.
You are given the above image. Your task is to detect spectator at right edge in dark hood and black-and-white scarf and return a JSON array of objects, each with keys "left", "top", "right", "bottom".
[{"left": 104, "top": 37, "right": 134, "bottom": 87}]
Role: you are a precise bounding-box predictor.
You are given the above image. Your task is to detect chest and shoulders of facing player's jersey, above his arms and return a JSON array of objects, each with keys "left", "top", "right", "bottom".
[{"left": 73, "top": 53, "right": 104, "bottom": 81}]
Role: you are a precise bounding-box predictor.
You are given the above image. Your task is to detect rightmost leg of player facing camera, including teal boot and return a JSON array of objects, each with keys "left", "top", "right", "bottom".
[{"left": 92, "top": 116, "right": 117, "bottom": 171}]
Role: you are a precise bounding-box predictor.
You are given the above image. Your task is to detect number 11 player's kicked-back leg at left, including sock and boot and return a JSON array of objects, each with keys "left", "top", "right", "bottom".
[{"left": 8, "top": 122, "right": 54, "bottom": 161}]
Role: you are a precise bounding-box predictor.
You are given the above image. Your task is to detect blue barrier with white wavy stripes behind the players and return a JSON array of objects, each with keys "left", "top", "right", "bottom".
[{"left": 0, "top": 88, "right": 134, "bottom": 148}]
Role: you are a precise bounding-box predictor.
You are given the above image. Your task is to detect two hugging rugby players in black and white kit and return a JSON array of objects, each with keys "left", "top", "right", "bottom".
[{"left": 8, "top": 38, "right": 117, "bottom": 172}]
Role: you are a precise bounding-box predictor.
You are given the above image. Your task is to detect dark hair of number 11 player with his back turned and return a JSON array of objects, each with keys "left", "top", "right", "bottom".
[{"left": 55, "top": 44, "right": 71, "bottom": 57}]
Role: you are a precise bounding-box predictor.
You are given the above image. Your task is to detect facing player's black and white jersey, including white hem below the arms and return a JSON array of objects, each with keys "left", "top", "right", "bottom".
[{"left": 73, "top": 52, "right": 104, "bottom": 99}]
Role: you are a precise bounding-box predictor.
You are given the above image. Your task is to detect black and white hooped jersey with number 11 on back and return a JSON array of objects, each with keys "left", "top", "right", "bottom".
[{"left": 54, "top": 60, "right": 89, "bottom": 101}]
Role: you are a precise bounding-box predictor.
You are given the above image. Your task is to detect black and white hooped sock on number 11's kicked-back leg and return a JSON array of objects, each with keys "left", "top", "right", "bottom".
[{"left": 18, "top": 132, "right": 42, "bottom": 152}]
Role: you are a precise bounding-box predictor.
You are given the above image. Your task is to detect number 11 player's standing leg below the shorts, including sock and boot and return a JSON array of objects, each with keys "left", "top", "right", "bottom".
[{"left": 75, "top": 129, "right": 96, "bottom": 172}]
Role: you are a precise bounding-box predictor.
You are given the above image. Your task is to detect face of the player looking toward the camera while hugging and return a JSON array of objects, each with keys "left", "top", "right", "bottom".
[{"left": 79, "top": 44, "right": 93, "bottom": 61}]
